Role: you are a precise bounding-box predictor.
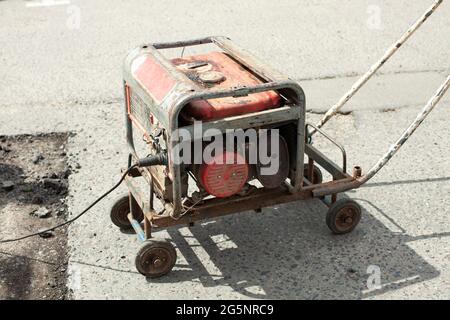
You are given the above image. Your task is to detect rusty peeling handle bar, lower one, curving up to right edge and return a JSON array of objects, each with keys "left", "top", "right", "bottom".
[{"left": 313, "top": 75, "right": 450, "bottom": 197}]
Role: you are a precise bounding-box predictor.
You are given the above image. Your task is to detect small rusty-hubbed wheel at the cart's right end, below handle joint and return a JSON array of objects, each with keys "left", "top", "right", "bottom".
[{"left": 326, "top": 199, "right": 361, "bottom": 234}]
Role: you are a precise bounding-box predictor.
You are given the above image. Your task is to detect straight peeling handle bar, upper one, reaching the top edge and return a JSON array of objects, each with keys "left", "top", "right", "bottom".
[{"left": 311, "top": 0, "right": 443, "bottom": 135}]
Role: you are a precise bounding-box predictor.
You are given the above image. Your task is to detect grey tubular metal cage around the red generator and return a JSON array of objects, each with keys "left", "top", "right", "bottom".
[{"left": 124, "top": 37, "right": 305, "bottom": 218}]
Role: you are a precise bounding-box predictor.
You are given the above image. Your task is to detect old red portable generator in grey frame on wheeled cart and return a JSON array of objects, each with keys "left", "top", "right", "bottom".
[{"left": 111, "top": 37, "right": 448, "bottom": 277}]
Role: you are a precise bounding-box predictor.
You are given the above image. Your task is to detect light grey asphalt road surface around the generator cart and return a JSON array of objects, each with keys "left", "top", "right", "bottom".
[{"left": 0, "top": 0, "right": 450, "bottom": 299}]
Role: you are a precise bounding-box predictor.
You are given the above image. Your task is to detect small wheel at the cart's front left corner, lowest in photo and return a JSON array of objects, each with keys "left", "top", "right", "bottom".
[{"left": 135, "top": 240, "right": 177, "bottom": 278}]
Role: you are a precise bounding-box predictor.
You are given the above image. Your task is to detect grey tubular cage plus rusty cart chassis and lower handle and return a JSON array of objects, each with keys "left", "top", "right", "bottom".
[{"left": 124, "top": 37, "right": 450, "bottom": 238}]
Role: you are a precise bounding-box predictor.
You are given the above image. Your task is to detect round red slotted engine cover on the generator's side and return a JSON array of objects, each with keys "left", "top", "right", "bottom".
[{"left": 199, "top": 151, "right": 249, "bottom": 198}]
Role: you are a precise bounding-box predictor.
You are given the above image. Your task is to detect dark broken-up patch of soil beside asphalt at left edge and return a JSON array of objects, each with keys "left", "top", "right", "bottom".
[{"left": 0, "top": 133, "right": 70, "bottom": 299}]
